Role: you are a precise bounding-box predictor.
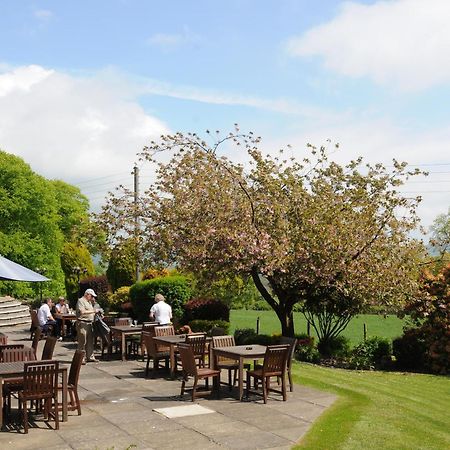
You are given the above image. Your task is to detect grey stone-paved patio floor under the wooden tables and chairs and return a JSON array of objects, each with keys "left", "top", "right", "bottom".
[{"left": 0, "top": 326, "right": 336, "bottom": 450}]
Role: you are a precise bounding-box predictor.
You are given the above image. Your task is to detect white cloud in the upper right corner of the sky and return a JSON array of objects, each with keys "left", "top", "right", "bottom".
[{"left": 286, "top": 0, "right": 450, "bottom": 90}]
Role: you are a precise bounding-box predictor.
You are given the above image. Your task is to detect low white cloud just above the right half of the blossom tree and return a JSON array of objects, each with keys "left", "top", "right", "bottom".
[{"left": 263, "top": 116, "right": 450, "bottom": 227}]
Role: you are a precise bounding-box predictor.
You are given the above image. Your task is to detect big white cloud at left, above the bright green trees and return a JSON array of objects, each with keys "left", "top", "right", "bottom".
[{"left": 0, "top": 66, "right": 169, "bottom": 207}]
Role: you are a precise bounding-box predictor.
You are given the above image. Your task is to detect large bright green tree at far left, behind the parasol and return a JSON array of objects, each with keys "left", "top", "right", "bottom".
[{"left": 0, "top": 151, "right": 96, "bottom": 297}]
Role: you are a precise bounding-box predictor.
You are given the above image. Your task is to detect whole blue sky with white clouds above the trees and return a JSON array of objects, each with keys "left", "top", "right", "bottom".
[{"left": 0, "top": 0, "right": 450, "bottom": 230}]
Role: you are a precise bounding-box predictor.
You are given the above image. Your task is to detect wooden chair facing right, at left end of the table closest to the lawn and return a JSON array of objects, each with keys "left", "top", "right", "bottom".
[{"left": 178, "top": 343, "right": 220, "bottom": 401}]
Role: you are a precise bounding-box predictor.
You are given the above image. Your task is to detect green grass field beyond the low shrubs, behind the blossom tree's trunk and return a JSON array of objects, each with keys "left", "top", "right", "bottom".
[{"left": 230, "top": 310, "right": 404, "bottom": 345}]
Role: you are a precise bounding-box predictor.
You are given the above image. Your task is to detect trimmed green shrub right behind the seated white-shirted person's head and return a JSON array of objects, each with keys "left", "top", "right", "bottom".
[{"left": 130, "top": 275, "right": 191, "bottom": 322}]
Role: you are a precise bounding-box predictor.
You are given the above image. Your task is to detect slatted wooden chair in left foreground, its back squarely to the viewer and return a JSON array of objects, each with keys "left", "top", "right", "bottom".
[{"left": 18, "top": 361, "right": 59, "bottom": 433}]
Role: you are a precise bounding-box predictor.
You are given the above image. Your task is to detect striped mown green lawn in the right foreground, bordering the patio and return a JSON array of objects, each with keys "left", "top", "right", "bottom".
[{"left": 293, "top": 362, "right": 450, "bottom": 450}]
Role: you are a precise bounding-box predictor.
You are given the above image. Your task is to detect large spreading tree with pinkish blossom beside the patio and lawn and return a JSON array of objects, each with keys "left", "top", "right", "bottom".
[{"left": 99, "top": 128, "right": 426, "bottom": 341}]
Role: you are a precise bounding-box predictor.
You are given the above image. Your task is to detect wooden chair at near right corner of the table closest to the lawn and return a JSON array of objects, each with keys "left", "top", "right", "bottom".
[{"left": 246, "top": 345, "right": 289, "bottom": 403}]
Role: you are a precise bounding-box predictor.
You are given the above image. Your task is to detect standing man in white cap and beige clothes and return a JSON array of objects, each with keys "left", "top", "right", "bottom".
[{"left": 76, "top": 289, "right": 98, "bottom": 362}]
